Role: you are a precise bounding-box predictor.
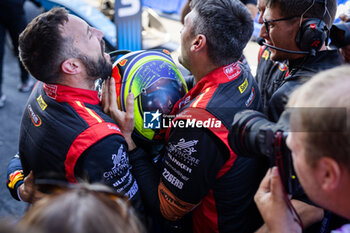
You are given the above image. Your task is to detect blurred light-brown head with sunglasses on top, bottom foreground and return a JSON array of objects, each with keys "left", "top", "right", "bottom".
[{"left": 18, "top": 183, "right": 145, "bottom": 233}]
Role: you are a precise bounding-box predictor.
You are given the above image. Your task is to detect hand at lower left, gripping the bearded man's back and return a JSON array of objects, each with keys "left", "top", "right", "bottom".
[{"left": 18, "top": 171, "right": 45, "bottom": 203}]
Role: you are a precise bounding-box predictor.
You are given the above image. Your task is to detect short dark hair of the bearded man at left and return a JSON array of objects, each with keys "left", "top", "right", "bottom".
[{"left": 19, "top": 8, "right": 68, "bottom": 83}]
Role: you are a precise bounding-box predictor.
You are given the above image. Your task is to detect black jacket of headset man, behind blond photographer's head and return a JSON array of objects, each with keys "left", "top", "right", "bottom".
[{"left": 268, "top": 50, "right": 342, "bottom": 122}]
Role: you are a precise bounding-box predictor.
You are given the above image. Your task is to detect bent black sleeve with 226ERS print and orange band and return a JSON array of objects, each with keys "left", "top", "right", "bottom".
[{"left": 131, "top": 125, "right": 229, "bottom": 221}]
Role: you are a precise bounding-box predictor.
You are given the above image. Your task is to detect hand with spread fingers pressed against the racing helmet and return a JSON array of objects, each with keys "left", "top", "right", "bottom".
[{"left": 102, "top": 78, "right": 136, "bottom": 150}]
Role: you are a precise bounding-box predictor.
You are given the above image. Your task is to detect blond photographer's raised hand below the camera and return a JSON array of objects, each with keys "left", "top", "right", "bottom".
[{"left": 254, "top": 167, "right": 302, "bottom": 233}]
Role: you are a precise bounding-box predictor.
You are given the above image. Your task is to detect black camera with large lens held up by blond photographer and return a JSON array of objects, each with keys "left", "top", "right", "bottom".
[{"left": 228, "top": 110, "right": 299, "bottom": 194}]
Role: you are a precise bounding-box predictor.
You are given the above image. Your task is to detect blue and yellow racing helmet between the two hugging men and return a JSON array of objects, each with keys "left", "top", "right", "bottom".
[{"left": 112, "top": 50, "right": 188, "bottom": 143}]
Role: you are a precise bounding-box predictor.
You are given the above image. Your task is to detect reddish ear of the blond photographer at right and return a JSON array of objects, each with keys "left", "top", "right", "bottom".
[{"left": 316, "top": 157, "right": 342, "bottom": 191}]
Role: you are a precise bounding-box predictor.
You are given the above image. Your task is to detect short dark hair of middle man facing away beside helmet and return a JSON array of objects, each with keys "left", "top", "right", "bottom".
[{"left": 191, "top": 0, "right": 253, "bottom": 66}]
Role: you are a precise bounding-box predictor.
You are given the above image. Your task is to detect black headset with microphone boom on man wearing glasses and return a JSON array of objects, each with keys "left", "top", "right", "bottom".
[{"left": 257, "top": 0, "right": 330, "bottom": 56}]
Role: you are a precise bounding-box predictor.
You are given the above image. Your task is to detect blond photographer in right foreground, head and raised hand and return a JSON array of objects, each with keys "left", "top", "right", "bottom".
[{"left": 255, "top": 66, "right": 350, "bottom": 233}]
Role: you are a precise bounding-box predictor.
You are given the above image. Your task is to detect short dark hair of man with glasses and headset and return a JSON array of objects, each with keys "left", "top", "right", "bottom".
[{"left": 266, "top": 0, "right": 337, "bottom": 28}]
